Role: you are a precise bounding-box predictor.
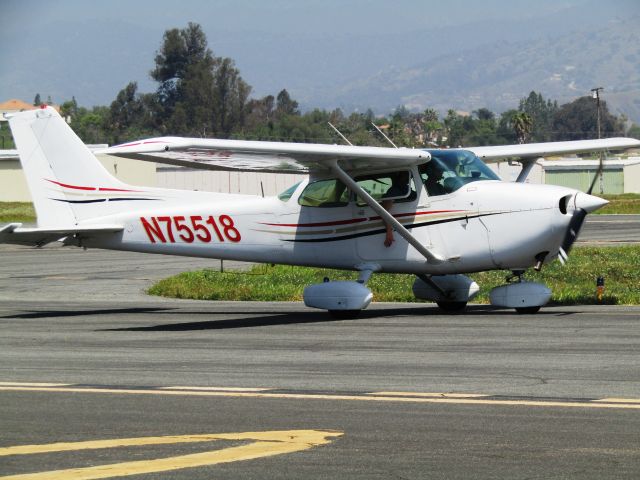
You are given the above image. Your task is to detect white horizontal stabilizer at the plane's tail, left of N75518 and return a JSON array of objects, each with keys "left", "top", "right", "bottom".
[{"left": 0, "top": 223, "right": 124, "bottom": 247}]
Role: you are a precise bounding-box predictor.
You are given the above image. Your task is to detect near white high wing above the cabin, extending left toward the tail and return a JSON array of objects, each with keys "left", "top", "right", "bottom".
[{"left": 99, "top": 137, "right": 431, "bottom": 173}]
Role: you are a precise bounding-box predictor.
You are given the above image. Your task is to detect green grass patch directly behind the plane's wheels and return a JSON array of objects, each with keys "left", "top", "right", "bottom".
[{"left": 148, "top": 246, "right": 640, "bottom": 305}]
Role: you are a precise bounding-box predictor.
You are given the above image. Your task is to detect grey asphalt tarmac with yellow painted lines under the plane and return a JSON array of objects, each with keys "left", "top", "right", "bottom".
[{"left": 0, "top": 218, "right": 640, "bottom": 479}]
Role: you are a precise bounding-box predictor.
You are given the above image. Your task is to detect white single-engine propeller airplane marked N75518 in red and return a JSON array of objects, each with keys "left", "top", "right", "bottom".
[{"left": 0, "top": 107, "right": 640, "bottom": 318}]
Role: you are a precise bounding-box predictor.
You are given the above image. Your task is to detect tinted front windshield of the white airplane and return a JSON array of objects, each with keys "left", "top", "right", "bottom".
[{"left": 419, "top": 149, "right": 500, "bottom": 196}]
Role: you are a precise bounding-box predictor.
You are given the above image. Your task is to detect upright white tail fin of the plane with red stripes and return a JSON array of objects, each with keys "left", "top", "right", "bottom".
[{"left": 9, "top": 107, "right": 129, "bottom": 228}]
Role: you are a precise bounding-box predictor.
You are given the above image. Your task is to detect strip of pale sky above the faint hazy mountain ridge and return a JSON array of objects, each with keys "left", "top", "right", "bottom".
[{"left": 0, "top": 0, "right": 600, "bottom": 34}]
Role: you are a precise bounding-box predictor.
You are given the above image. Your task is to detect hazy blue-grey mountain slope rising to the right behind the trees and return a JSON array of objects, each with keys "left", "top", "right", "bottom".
[{"left": 312, "top": 17, "right": 640, "bottom": 123}]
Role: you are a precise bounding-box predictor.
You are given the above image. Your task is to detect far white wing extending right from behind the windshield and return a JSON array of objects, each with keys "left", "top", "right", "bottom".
[{"left": 465, "top": 137, "right": 640, "bottom": 163}]
